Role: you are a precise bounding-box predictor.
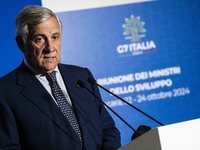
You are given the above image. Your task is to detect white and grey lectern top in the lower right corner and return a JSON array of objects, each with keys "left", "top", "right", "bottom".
[{"left": 119, "top": 119, "right": 200, "bottom": 150}]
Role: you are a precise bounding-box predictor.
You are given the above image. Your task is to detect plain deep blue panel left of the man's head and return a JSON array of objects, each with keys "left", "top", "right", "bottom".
[{"left": 0, "top": 0, "right": 41, "bottom": 77}]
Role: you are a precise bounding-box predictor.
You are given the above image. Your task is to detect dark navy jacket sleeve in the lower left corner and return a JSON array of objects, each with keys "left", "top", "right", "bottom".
[{"left": 0, "top": 97, "right": 20, "bottom": 150}]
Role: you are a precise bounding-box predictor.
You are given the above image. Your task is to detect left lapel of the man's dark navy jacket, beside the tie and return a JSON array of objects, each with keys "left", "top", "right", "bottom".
[{"left": 17, "top": 66, "right": 81, "bottom": 144}]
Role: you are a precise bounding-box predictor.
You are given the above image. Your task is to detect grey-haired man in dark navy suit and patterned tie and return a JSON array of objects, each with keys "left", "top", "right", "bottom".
[{"left": 0, "top": 6, "right": 120, "bottom": 150}]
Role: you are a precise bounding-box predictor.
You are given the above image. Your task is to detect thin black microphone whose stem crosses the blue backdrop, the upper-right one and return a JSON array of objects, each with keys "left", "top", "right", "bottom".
[{"left": 88, "top": 78, "right": 164, "bottom": 126}]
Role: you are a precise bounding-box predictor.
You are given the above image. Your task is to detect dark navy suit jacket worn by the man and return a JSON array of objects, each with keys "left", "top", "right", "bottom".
[{"left": 0, "top": 63, "right": 120, "bottom": 150}]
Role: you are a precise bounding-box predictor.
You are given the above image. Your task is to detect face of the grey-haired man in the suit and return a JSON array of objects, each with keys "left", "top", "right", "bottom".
[{"left": 24, "top": 17, "right": 61, "bottom": 73}]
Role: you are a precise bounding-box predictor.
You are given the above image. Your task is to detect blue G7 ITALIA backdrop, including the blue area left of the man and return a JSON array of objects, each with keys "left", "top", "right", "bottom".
[{"left": 0, "top": 0, "right": 200, "bottom": 145}]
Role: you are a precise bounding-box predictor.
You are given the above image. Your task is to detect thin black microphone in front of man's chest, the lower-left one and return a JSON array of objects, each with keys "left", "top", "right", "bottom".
[{"left": 77, "top": 80, "right": 140, "bottom": 137}]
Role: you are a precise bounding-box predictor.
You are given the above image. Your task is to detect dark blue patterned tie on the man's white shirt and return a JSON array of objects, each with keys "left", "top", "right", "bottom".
[{"left": 46, "top": 71, "right": 82, "bottom": 141}]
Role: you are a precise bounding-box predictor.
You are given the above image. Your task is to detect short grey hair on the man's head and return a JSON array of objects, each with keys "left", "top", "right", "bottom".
[{"left": 15, "top": 5, "right": 62, "bottom": 44}]
